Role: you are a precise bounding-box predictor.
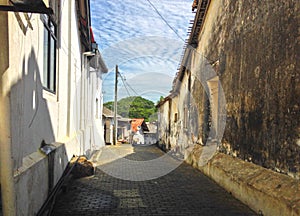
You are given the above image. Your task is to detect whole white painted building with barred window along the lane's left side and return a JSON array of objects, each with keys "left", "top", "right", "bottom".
[{"left": 0, "top": 0, "right": 107, "bottom": 215}]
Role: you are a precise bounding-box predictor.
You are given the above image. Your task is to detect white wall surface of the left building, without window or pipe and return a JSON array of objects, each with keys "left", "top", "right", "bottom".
[{"left": 0, "top": 0, "right": 108, "bottom": 215}]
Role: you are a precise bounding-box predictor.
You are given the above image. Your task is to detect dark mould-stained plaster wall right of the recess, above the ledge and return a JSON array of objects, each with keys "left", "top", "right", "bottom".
[{"left": 194, "top": 0, "right": 300, "bottom": 177}]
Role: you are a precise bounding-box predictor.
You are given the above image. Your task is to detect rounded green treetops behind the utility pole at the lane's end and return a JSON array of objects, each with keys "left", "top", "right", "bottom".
[{"left": 103, "top": 96, "right": 157, "bottom": 121}]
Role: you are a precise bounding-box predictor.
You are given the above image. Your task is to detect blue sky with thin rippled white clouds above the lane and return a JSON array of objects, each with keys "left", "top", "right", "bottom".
[{"left": 91, "top": 0, "right": 194, "bottom": 102}]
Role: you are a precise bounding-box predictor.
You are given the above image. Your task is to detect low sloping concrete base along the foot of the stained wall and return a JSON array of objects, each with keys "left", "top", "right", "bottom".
[{"left": 186, "top": 145, "right": 300, "bottom": 216}]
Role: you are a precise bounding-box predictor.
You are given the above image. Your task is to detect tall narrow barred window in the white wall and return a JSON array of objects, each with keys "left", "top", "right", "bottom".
[{"left": 42, "top": 15, "right": 57, "bottom": 93}]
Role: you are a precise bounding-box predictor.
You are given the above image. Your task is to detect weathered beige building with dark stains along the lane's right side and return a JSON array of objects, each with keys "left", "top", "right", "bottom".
[{"left": 158, "top": 0, "right": 300, "bottom": 215}]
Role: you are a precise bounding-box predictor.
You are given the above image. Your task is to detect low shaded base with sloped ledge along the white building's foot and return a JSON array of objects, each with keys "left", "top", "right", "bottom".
[{"left": 14, "top": 140, "right": 76, "bottom": 216}]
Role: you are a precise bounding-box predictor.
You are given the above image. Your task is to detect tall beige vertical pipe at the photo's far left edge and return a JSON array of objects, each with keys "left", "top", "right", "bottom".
[{"left": 0, "top": 0, "right": 16, "bottom": 216}]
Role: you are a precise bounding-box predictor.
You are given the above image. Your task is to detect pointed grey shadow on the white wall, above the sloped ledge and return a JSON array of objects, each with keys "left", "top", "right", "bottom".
[{"left": 10, "top": 50, "right": 56, "bottom": 169}]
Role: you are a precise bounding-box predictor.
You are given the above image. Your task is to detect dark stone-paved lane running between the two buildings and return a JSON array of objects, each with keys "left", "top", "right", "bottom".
[{"left": 53, "top": 145, "right": 256, "bottom": 216}]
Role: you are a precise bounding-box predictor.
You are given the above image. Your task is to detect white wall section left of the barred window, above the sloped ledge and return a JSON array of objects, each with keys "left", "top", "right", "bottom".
[{"left": 6, "top": 10, "right": 58, "bottom": 169}]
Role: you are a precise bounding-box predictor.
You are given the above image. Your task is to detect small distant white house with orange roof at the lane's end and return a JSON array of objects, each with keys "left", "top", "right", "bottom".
[{"left": 130, "top": 119, "right": 149, "bottom": 144}]
